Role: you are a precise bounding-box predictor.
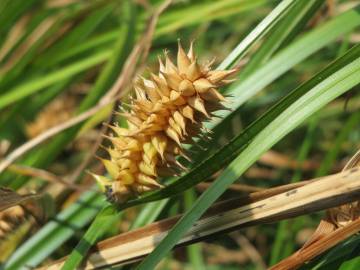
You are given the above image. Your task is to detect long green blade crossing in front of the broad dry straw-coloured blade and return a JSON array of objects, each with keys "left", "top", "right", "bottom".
[{"left": 137, "top": 46, "right": 360, "bottom": 269}]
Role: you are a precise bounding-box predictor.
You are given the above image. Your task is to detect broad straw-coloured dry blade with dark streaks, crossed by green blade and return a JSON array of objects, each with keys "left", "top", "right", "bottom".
[{"left": 46, "top": 169, "right": 360, "bottom": 269}]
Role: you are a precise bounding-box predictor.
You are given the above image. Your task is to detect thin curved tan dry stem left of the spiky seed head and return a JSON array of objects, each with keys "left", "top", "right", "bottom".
[{"left": 0, "top": 0, "right": 172, "bottom": 173}]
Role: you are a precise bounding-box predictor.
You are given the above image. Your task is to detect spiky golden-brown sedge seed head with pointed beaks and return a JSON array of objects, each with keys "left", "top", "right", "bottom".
[{"left": 94, "top": 42, "right": 237, "bottom": 203}]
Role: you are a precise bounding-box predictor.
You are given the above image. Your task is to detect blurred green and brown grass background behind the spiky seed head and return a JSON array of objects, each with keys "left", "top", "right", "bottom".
[{"left": 0, "top": 0, "right": 360, "bottom": 269}]
